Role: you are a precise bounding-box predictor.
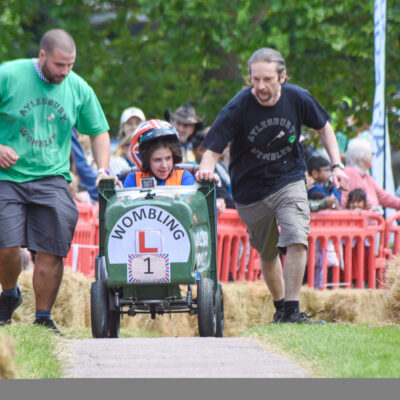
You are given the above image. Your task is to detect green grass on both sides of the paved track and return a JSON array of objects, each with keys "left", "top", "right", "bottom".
[{"left": 1, "top": 324, "right": 400, "bottom": 379}]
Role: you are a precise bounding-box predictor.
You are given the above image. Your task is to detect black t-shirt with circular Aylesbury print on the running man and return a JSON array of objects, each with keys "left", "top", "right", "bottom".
[{"left": 202, "top": 83, "right": 329, "bottom": 204}]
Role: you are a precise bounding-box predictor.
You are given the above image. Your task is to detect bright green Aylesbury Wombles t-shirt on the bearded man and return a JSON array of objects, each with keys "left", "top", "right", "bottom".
[{"left": 0, "top": 59, "right": 109, "bottom": 182}]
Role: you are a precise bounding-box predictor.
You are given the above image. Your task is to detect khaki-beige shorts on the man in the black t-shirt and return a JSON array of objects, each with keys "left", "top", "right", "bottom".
[{"left": 236, "top": 181, "right": 310, "bottom": 261}]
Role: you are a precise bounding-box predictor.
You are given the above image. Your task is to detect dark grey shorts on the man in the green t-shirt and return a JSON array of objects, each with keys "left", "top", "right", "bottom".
[{"left": 0, "top": 176, "right": 78, "bottom": 257}]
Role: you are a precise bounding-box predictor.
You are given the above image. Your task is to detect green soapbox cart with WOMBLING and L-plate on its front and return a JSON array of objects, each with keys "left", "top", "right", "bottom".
[{"left": 91, "top": 174, "right": 224, "bottom": 338}]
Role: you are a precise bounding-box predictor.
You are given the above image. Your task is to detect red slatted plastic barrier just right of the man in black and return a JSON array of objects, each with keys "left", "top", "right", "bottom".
[{"left": 307, "top": 210, "right": 390, "bottom": 289}]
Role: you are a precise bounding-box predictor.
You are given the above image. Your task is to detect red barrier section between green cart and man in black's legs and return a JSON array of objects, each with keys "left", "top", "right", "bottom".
[{"left": 217, "top": 209, "right": 261, "bottom": 282}]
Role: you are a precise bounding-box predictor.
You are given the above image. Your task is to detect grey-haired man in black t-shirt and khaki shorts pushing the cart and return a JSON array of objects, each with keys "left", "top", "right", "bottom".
[{"left": 196, "top": 48, "right": 348, "bottom": 323}]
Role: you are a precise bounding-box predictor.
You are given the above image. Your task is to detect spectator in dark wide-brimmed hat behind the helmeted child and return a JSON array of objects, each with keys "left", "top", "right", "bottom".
[{"left": 164, "top": 104, "right": 203, "bottom": 162}]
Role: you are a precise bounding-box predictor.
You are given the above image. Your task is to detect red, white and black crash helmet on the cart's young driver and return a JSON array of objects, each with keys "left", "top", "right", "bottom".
[{"left": 130, "top": 119, "right": 180, "bottom": 168}]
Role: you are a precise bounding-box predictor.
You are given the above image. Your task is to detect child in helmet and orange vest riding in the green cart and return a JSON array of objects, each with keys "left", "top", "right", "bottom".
[{"left": 124, "top": 119, "right": 194, "bottom": 187}]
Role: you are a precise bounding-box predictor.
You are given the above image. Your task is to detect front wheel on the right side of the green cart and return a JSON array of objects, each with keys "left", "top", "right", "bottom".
[{"left": 197, "top": 278, "right": 216, "bottom": 337}]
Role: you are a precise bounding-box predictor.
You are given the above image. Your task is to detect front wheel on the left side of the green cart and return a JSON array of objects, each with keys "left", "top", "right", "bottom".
[{"left": 90, "top": 281, "right": 109, "bottom": 338}]
